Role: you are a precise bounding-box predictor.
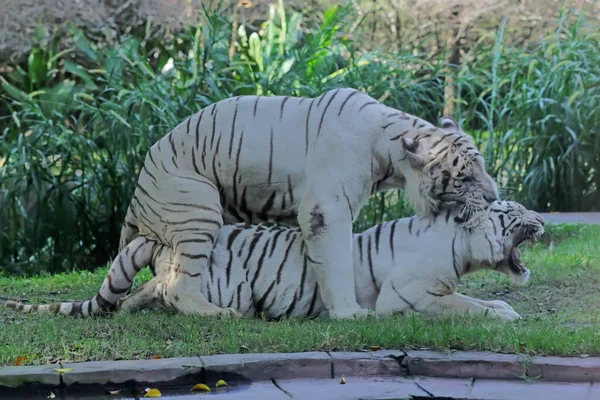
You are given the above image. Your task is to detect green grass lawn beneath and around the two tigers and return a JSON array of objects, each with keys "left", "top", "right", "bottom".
[{"left": 0, "top": 225, "right": 600, "bottom": 365}]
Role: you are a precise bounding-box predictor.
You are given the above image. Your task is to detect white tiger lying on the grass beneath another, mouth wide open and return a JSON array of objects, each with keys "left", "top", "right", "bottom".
[{"left": 7, "top": 201, "right": 544, "bottom": 320}]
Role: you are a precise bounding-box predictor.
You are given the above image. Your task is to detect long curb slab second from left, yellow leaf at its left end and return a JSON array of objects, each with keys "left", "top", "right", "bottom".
[{"left": 63, "top": 357, "right": 201, "bottom": 385}]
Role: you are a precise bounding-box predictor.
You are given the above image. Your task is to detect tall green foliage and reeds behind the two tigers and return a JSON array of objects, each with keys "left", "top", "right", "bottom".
[{"left": 0, "top": 1, "right": 600, "bottom": 274}]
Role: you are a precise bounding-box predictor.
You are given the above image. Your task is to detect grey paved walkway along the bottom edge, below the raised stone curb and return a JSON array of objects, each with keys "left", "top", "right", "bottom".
[{"left": 3, "top": 377, "right": 600, "bottom": 400}]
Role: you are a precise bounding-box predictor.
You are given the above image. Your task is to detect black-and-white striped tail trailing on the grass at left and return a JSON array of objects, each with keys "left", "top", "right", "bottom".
[{"left": 5, "top": 236, "right": 156, "bottom": 317}]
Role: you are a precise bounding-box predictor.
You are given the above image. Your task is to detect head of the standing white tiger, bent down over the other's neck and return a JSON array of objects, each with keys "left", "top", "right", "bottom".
[{"left": 402, "top": 117, "right": 499, "bottom": 228}]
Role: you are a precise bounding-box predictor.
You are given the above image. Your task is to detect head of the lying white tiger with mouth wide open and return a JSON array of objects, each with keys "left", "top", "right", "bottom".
[{"left": 469, "top": 201, "right": 545, "bottom": 285}]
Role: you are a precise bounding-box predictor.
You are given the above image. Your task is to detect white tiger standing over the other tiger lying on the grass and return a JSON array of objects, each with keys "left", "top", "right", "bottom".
[{"left": 12, "top": 89, "right": 498, "bottom": 318}]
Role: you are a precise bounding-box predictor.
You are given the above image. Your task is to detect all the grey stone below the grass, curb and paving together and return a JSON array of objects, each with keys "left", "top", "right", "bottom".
[{"left": 0, "top": 350, "right": 600, "bottom": 400}]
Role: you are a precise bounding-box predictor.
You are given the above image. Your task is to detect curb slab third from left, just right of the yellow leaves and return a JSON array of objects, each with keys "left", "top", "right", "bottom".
[{"left": 200, "top": 352, "right": 332, "bottom": 382}]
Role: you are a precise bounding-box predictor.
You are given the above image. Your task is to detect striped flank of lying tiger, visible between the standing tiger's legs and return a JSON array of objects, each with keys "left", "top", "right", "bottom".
[{"left": 202, "top": 224, "right": 327, "bottom": 319}]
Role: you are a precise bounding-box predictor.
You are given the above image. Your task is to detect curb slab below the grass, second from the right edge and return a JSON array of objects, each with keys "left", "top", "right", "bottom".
[{"left": 402, "top": 351, "right": 526, "bottom": 379}]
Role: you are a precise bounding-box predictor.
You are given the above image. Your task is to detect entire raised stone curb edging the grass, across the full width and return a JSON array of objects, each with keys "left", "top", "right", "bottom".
[{"left": 0, "top": 350, "right": 600, "bottom": 388}]
